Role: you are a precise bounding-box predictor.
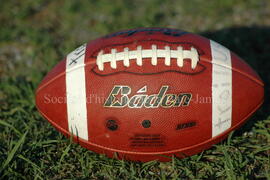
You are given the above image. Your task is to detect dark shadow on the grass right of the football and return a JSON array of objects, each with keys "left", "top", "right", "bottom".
[{"left": 200, "top": 26, "right": 270, "bottom": 134}]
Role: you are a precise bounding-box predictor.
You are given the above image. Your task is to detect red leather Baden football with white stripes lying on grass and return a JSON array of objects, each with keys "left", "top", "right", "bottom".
[{"left": 36, "top": 28, "right": 264, "bottom": 162}]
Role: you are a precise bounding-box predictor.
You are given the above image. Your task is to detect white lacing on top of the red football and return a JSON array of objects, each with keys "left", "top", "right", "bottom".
[{"left": 96, "top": 45, "right": 199, "bottom": 71}]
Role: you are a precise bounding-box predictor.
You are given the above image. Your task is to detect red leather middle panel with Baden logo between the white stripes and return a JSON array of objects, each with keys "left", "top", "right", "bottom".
[{"left": 85, "top": 38, "right": 211, "bottom": 152}]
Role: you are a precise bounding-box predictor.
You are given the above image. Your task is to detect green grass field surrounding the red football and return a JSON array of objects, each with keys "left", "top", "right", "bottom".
[{"left": 0, "top": 0, "right": 270, "bottom": 179}]
